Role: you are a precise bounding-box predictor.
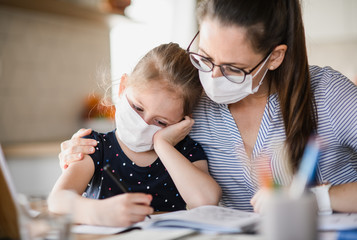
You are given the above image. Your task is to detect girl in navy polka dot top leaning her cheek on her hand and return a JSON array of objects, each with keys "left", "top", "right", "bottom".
[{"left": 48, "top": 43, "right": 221, "bottom": 226}]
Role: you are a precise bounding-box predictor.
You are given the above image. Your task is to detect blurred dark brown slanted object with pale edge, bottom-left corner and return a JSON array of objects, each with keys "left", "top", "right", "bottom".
[{"left": 0, "top": 145, "right": 20, "bottom": 239}]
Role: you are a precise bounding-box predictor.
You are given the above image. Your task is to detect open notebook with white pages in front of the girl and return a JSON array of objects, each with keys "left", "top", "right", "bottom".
[{"left": 72, "top": 206, "right": 261, "bottom": 234}]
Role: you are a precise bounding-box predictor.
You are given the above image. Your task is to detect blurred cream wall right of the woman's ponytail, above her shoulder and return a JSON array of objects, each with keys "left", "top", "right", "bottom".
[{"left": 303, "top": 0, "right": 357, "bottom": 83}]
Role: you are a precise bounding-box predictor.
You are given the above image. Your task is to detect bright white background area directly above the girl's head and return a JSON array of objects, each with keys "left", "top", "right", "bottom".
[{"left": 110, "top": 0, "right": 197, "bottom": 102}]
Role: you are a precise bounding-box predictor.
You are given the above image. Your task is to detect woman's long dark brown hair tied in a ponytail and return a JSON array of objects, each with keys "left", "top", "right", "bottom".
[{"left": 198, "top": 0, "right": 317, "bottom": 170}]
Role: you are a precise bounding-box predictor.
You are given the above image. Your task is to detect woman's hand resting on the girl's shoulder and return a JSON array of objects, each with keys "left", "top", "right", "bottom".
[{"left": 58, "top": 128, "right": 97, "bottom": 171}]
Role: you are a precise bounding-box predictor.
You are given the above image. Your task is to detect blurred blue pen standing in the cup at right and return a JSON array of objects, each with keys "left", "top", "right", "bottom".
[{"left": 289, "top": 137, "right": 320, "bottom": 199}]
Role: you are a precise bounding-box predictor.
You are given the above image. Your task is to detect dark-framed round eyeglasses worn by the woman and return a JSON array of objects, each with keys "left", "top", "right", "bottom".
[{"left": 186, "top": 31, "right": 268, "bottom": 83}]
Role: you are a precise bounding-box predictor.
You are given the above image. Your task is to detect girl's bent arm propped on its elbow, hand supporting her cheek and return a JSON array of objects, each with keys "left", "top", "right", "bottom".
[{"left": 154, "top": 117, "right": 221, "bottom": 208}]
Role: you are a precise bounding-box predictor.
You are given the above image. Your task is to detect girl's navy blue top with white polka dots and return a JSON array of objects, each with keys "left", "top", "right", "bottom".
[{"left": 83, "top": 130, "right": 207, "bottom": 211}]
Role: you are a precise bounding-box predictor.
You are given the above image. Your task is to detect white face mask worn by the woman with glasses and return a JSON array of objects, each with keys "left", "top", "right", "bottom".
[{"left": 199, "top": 55, "right": 270, "bottom": 104}]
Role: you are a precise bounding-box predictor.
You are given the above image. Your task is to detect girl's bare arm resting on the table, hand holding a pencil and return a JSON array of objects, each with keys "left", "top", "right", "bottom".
[{"left": 48, "top": 155, "right": 153, "bottom": 227}]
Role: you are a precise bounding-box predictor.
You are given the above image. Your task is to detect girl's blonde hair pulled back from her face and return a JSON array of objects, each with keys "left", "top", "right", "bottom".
[{"left": 128, "top": 43, "right": 202, "bottom": 116}]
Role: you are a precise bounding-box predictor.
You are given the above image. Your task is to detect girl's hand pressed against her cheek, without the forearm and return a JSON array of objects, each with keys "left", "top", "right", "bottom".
[{"left": 154, "top": 116, "right": 195, "bottom": 146}]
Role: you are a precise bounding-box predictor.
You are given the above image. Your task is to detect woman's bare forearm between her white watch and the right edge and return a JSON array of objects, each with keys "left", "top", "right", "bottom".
[{"left": 329, "top": 182, "right": 357, "bottom": 212}]
